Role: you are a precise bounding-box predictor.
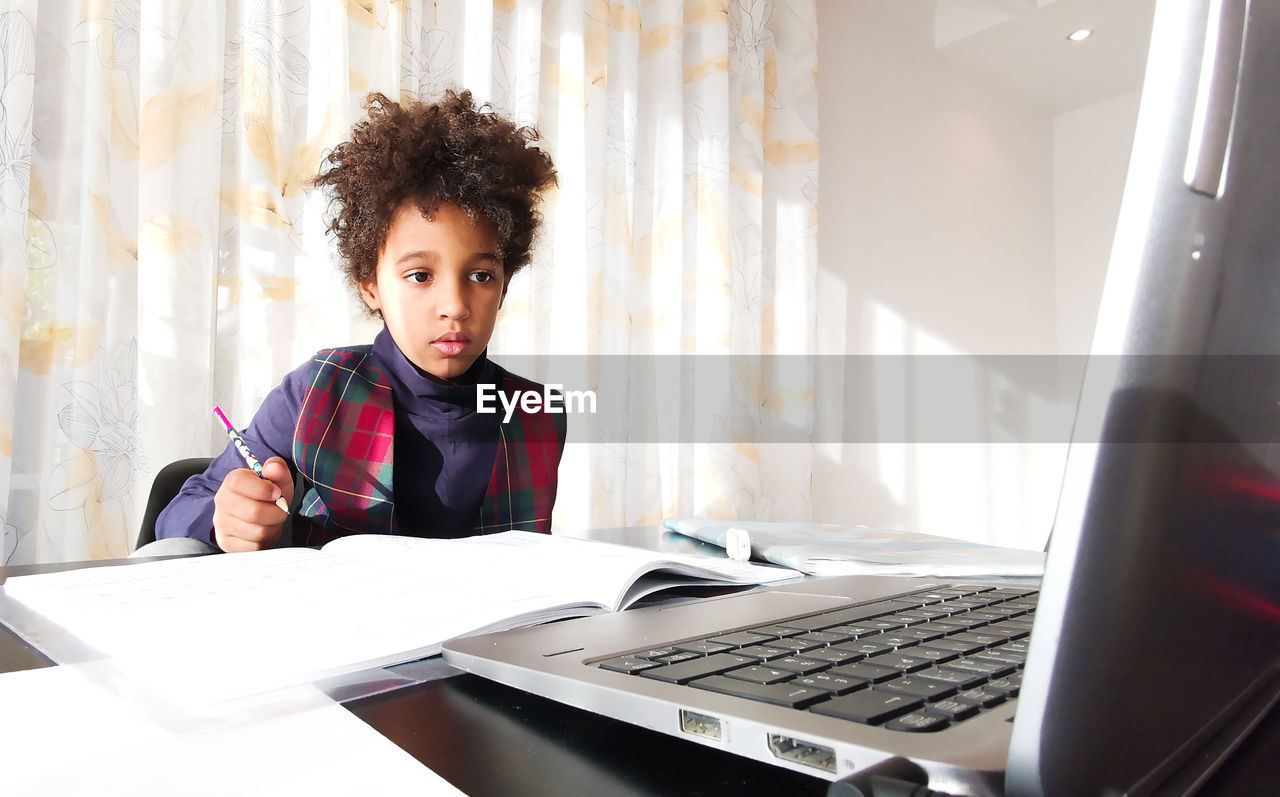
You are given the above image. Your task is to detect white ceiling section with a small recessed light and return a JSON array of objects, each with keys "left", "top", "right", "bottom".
[{"left": 916, "top": 0, "right": 1155, "bottom": 114}]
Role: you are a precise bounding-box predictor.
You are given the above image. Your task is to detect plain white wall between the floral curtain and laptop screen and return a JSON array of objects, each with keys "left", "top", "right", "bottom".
[{"left": 812, "top": 0, "right": 1135, "bottom": 548}]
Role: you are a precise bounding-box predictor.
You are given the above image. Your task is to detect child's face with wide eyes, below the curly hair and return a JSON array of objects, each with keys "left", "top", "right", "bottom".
[{"left": 360, "top": 202, "right": 507, "bottom": 381}]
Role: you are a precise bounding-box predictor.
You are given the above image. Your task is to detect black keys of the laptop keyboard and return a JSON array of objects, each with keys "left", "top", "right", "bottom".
[{"left": 596, "top": 585, "right": 1037, "bottom": 733}]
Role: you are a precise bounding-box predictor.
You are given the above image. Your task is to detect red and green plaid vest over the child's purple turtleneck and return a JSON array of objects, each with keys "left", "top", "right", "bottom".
[{"left": 293, "top": 345, "right": 567, "bottom": 545}]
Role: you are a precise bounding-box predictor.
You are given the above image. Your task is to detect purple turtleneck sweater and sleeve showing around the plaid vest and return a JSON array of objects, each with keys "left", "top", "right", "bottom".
[{"left": 156, "top": 327, "right": 502, "bottom": 544}]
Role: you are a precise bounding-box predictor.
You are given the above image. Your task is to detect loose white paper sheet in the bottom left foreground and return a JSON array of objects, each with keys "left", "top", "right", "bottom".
[{"left": 0, "top": 667, "right": 462, "bottom": 797}]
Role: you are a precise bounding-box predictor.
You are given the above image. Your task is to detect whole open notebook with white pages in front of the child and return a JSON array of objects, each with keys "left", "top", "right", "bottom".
[{"left": 4, "top": 532, "right": 799, "bottom": 713}]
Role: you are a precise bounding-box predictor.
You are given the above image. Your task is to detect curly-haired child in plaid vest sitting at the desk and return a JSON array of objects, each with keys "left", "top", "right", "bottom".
[{"left": 147, "top": 91, "right": 566, "bottom": 554}]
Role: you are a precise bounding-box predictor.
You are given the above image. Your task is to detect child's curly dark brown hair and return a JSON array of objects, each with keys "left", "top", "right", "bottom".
[{"left": 312, "top": 90, "right": 556, "bottom": 305}]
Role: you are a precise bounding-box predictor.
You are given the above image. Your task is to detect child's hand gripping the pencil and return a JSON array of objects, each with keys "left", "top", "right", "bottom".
[{"left": 214, "top": 457, "right": 293, "bottom": 553}]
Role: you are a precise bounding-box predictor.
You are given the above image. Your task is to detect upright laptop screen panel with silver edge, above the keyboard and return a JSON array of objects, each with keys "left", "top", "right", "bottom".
[{"left": 1009, "top": 0, "right": 1280, "bottom": 793}]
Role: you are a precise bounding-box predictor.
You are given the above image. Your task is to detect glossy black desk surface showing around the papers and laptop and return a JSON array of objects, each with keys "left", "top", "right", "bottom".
[{"left": 0, "top": 528, "right": 1280, "bottom": 797}]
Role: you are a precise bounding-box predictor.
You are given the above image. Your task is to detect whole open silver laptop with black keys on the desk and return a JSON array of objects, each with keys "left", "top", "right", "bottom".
[{"left": 444, "top": 0, "right": 1280, "bottom": 796}]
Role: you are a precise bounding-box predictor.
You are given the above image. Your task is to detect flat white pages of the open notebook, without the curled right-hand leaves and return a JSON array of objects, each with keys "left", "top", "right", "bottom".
[{"left": 5, "top": 549, "right": 609, "bottom": 706}]
